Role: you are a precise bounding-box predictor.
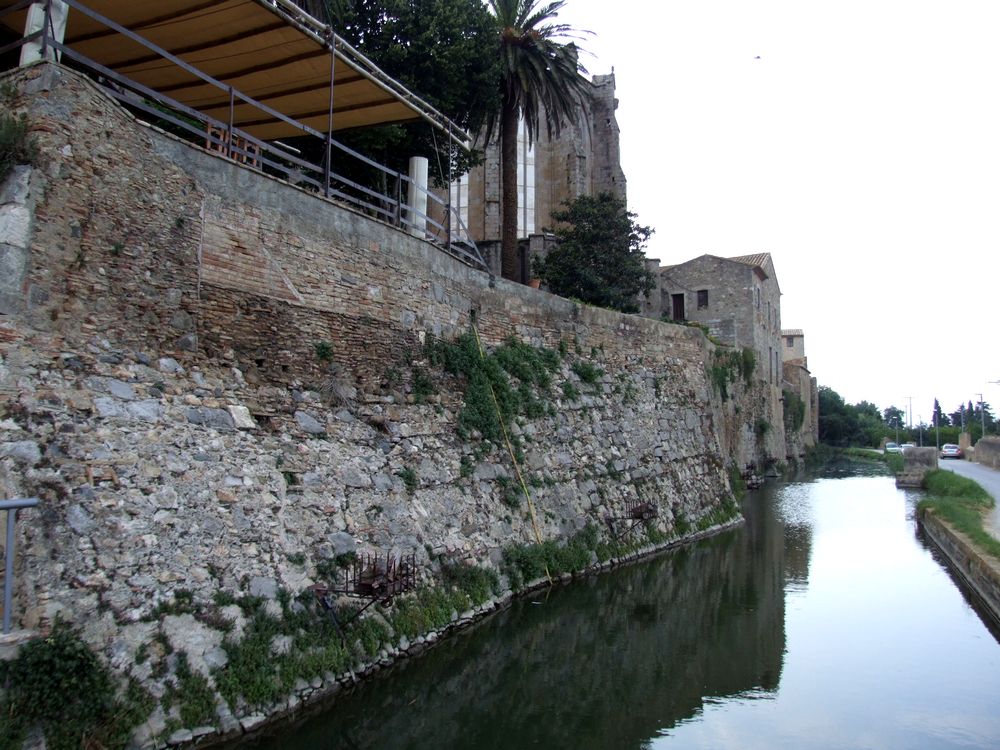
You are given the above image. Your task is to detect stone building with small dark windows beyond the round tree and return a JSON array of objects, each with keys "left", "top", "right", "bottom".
[{"left": 660, "top": 253, "right": 782, "bottom": 387}]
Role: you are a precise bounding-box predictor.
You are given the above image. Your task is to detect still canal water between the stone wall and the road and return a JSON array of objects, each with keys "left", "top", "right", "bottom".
[{"left": 248, "top": 465, "right": 1000, "bottom": 750}]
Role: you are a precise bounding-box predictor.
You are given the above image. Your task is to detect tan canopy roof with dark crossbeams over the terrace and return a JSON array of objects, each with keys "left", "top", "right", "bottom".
[{"left": 0, "top": 0, "right": 464, "bottom": 140}]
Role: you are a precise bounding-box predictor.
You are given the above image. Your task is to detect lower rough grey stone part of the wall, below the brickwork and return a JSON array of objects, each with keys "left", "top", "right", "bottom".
[{"left": 0, "top": 314, "right": 744, "bottom": 746}]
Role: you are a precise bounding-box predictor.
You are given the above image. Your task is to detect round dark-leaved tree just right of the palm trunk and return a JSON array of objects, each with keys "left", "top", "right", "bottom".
[{"left": 533, "top": 193, "right": 656, "bottom": 312}]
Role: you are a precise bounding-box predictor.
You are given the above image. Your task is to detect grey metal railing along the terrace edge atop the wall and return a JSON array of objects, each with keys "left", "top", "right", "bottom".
[{"left": 0, "top": 0, "right": 492, "bottom": 275}]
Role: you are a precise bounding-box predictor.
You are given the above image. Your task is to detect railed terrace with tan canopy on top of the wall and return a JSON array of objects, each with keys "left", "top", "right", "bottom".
[{"left": 0, "top": 0, "right": 488, "bottom": 271}]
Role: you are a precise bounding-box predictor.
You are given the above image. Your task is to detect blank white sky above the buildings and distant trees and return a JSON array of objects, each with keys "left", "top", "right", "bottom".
[{"left": 559, "top": 0, "right": 1000, "bottom": 423}]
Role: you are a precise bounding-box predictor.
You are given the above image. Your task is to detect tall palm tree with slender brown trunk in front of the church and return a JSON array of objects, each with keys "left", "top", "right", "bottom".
[{"left": 486, "top": 0, "right": 589, "bottom": 279}]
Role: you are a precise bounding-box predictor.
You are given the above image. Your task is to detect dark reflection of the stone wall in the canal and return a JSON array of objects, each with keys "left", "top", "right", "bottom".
[{"left": 264, "top": 506, "right": 785, "bottom": 748}]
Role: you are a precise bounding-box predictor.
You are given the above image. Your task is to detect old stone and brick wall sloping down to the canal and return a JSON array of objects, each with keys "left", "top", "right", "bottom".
[{"left": 0, "top": 64, "right": 734, "bottom": 744}]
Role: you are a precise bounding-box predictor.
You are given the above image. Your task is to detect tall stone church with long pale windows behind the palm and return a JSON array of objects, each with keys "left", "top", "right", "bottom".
[{"left": 451, "top": 73, "right": 626, "bottom": 281}]
